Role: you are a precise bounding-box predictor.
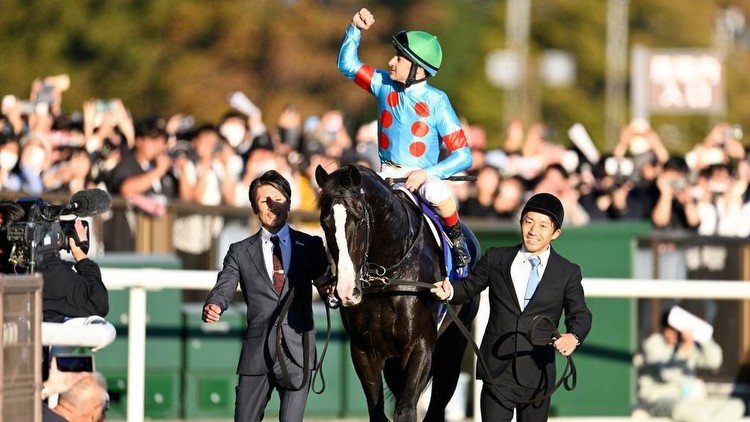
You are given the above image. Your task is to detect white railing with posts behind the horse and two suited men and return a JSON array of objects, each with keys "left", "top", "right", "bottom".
[{"left": 102, "top": 268, "right": 750, "bottom": 422}]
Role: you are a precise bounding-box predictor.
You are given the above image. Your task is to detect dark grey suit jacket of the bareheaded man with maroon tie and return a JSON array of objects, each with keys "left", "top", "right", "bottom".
[{"left": 206, "top": 228, "right": 328, "bottom": 375}]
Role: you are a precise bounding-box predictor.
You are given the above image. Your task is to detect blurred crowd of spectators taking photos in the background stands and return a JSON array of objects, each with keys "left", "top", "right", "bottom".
[{"left": 0, "top": 75, "right": 750, "bottom": 254}]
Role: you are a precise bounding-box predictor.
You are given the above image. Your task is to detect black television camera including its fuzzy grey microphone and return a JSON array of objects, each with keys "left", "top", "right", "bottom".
[{"left": 6, "top": 189, "right": 112, "bottom": 273}]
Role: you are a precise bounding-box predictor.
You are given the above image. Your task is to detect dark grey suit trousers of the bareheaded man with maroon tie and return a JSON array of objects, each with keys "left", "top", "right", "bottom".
[{"left": 234, "top": 359, "right": 310, "bottom": 422}]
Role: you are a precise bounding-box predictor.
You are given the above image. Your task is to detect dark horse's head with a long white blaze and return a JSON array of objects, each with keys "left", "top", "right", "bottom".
[{"left": 315, "top": 166, "right": 372, "bottom": 306}]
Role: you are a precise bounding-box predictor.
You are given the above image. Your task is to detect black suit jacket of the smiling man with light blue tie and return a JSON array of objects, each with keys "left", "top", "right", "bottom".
[{"left": 451, "top": 244, "right": 591, "bottom": 396}]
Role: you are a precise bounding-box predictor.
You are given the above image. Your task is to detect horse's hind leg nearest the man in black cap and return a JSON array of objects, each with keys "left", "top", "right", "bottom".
[{"left": 424, "top": 298, "right": 479, "bottom": 422}]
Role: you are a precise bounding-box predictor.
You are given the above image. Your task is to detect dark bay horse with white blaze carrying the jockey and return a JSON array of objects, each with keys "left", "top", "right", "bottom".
[{"left": 315, "top": 166, "right": 479, "bottom": 421}]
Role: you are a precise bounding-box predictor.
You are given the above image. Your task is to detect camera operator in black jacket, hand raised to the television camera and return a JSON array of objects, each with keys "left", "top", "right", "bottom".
[{"left": 37, "top": 219, "right": 109, "bottom": 322}]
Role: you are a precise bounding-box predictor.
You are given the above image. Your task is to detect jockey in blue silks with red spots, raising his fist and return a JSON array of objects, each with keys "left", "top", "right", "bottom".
[{"left": 338, "top": 9, "right": 472, "bottom": 268}]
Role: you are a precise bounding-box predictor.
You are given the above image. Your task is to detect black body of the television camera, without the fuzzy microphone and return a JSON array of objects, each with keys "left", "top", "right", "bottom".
[{"left": 6, "top": 198, "right": 89, "bottom": 272}]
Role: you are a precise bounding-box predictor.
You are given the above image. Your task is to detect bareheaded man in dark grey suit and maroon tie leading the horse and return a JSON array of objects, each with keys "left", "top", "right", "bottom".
[{"left": 203, "top": 170, "right": 328, "bottom": 422}]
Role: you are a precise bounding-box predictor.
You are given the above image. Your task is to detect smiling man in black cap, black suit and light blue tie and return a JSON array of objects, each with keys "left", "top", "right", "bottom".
[{"left": 432, "top": 193, "right": 592, "bottom": 422}]
